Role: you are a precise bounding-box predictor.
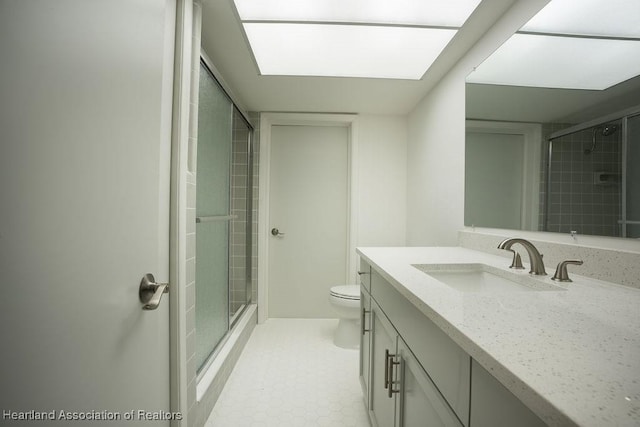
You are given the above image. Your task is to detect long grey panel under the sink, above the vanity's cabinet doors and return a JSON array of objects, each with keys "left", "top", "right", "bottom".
[{"left": 371, "top": 269, "right": 471, "bottom": 426}]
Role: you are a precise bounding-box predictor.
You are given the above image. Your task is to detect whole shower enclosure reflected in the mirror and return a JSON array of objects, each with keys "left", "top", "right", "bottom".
[{"left": 543, "top": 108, "right": 640, "bottom": 238}]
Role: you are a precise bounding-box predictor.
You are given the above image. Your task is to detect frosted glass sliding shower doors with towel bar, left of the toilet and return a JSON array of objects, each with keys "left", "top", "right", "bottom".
[{"left": 195, "top": 62, "right": 253, "bottom": 373}]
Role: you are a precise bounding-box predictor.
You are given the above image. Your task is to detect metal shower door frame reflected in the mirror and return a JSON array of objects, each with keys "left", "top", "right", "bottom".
[{"left": 543, "top": 105, "right": 640, "bottom": 238}]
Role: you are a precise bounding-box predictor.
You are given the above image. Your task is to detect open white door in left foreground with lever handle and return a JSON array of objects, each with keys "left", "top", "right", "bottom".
[{"left": 0, "top": 0, "right": 175, "bottom": 426}]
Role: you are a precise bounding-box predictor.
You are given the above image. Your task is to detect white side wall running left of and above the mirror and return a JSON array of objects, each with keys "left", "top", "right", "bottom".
[{"left": 407, "top": 0, "right": 547, "bottom": 246}]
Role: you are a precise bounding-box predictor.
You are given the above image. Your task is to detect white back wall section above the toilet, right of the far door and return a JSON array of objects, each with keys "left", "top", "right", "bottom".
[{"left": 356, "top": 115, "right": 407, "bottom": 246}]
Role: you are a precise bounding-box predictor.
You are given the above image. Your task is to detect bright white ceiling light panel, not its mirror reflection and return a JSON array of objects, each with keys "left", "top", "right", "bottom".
[{"left": 235, "top": 0, "right": 480, "bottom": 80}]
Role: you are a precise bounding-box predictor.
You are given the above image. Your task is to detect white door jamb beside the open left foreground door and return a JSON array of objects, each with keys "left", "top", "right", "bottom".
[{"left": 167, "top": 0, "right": 195, "bottom": 427}]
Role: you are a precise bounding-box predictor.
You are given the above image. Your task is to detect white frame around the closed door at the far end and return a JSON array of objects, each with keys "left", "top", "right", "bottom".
[{"left": 258, "top": 113, "right": 358, "bottom": 323}]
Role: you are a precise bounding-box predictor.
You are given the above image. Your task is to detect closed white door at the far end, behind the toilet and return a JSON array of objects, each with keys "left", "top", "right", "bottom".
[{"left": 268, "top": 126, "right": 349, "bottom": 318}]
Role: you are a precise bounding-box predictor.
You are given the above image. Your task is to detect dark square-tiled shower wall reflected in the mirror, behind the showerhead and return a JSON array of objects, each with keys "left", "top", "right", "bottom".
[{"left": 540, "top": 123, "right": 622, "bottom": 236}]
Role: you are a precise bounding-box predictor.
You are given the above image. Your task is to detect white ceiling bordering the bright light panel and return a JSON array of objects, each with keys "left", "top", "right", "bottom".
[{"left": 202, "top": 0, "right": 515, "bottom": 114}]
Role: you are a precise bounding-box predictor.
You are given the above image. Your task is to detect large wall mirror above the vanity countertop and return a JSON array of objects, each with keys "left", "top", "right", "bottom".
[{"left": 465, "top": 2, "right": 640, "bottom": 238}]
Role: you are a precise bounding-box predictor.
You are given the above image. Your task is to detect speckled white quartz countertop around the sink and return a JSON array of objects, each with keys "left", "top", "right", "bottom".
[{"left": 357, "top": 247, "right": 640, "bottom": 427}]
